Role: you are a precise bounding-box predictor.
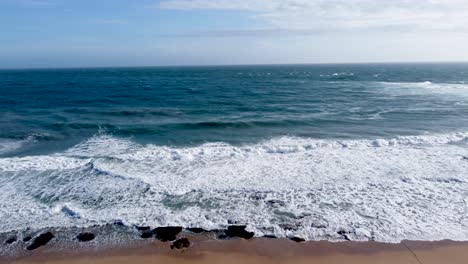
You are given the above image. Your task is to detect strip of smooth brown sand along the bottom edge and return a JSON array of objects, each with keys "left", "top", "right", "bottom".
[{"left": 1, "top": 236, "right": 468, "bottom": 264}]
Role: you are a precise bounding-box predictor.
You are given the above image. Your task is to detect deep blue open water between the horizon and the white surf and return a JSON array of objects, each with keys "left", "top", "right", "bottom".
[{"left": 0, "top": 64, "right": 468, "bottom": 155}]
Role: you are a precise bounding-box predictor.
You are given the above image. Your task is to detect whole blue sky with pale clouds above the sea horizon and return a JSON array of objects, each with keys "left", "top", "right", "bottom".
[{"left": 0, "top": 0, "right": 468, "bottom": 68}]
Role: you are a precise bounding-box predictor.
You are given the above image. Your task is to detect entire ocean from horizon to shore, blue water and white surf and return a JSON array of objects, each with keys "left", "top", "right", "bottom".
[{"left": 0, "top": 63, "right": 468, "bottom": 242}]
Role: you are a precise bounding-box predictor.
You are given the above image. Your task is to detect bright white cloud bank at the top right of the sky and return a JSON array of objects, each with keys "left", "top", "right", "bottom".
[{"left": 157, "top": 0, "right": 468, "bottom": 31}]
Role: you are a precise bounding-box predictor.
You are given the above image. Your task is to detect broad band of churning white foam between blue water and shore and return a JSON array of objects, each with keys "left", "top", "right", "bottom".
[{"left": 0, "top": 133, "right": 468, "bottom": 242}]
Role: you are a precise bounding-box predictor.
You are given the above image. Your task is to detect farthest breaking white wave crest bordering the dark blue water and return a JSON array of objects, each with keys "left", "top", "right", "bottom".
[{"left": 60, "top": 132, "right": 468, "bottom": 157}]
